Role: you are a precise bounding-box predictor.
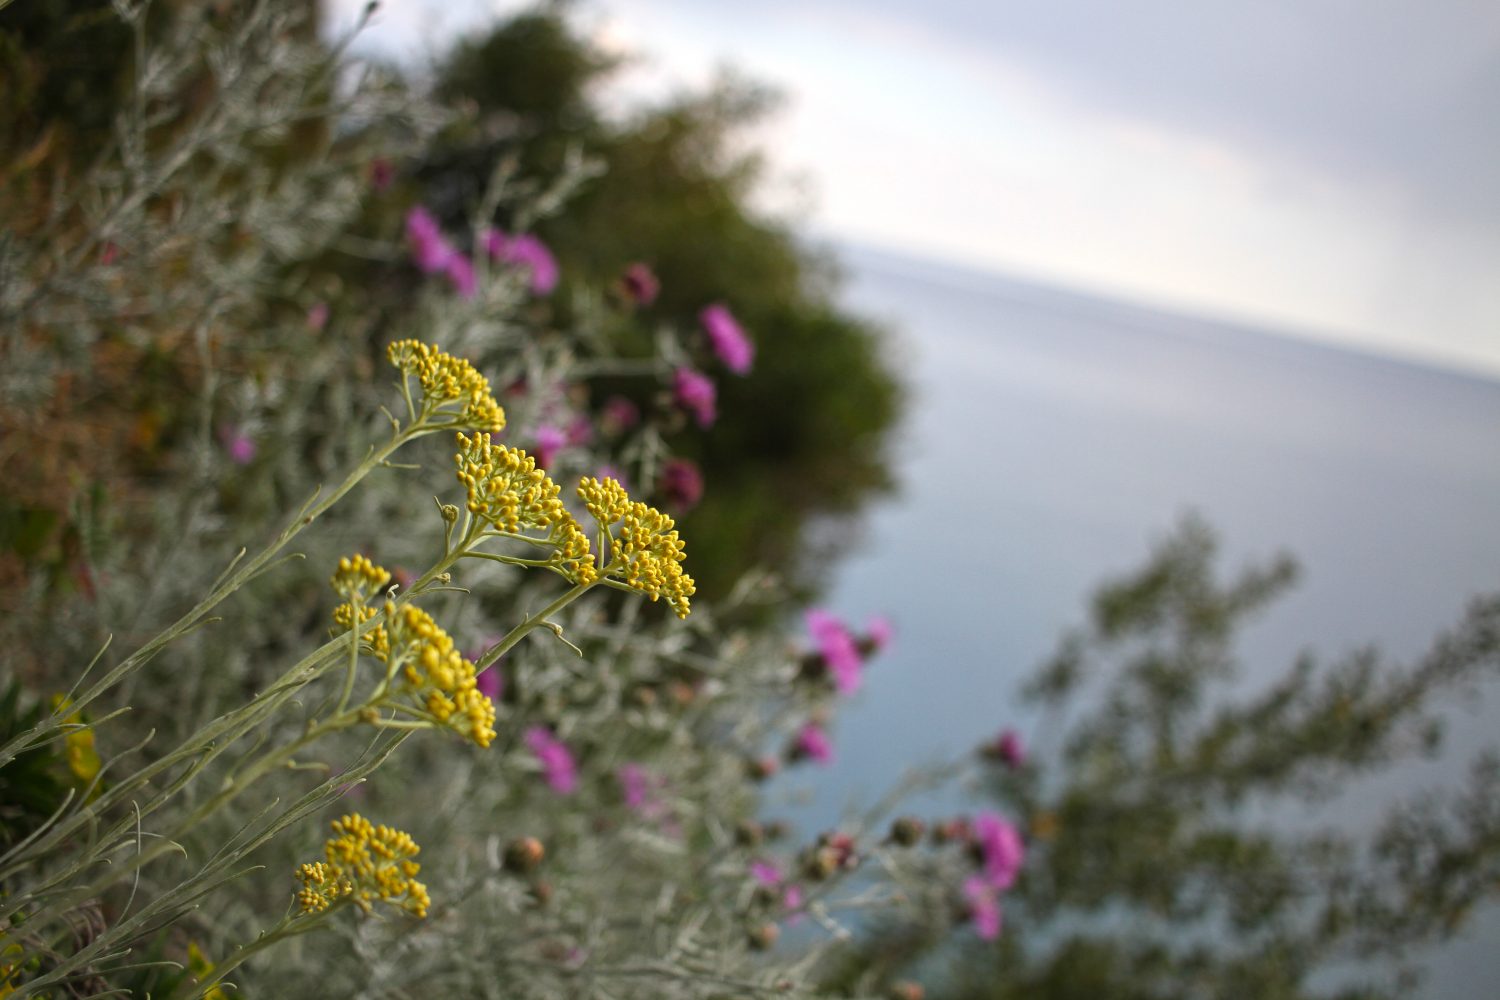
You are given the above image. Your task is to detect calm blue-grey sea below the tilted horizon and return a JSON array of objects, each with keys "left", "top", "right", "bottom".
[{"left": 782, "top": 239, "right": 1500, "bottom": 996}]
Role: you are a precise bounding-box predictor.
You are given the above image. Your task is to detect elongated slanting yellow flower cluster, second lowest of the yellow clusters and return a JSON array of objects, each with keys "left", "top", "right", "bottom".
[{"left": 386, "top": 604, "right": 495, "bottom": 747}]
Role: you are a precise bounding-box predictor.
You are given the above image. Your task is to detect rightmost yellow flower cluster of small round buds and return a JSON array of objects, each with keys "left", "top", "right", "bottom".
[{"left": 578, "top": 477, "right": 696, "bottom": 618}]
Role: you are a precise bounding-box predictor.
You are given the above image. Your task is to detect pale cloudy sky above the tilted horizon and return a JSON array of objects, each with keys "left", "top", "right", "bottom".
[{"left": 330, "top": 0, "right": 1500, "bottom": 375}]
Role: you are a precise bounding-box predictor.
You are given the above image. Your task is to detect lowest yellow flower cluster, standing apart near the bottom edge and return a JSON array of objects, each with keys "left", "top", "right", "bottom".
[{"left": 297, "top": 813, "right": 432, "bottom": 916}]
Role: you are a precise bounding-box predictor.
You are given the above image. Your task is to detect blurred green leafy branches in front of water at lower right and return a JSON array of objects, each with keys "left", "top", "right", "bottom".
[{"left": 831, "top": 520, "right": 1500, "bottom": 1000}]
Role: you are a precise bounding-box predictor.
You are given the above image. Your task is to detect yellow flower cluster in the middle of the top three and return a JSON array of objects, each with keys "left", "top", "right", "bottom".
[{"left": 455, "top": 433, "right": 599, "bottom": 583}]
